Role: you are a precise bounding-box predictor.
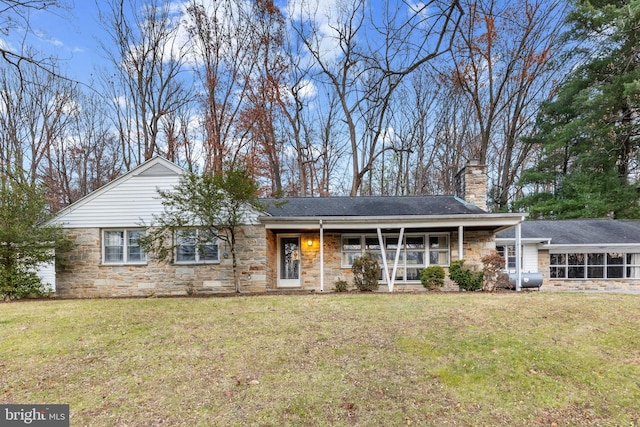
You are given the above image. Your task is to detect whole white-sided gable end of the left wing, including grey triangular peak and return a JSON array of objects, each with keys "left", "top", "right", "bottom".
[{"left": 49, "top": 156, "right": 185, "bottom": 228}]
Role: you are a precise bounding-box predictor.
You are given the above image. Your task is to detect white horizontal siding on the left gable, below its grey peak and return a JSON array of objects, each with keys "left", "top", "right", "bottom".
[{"left": 57, "top": 174, "right": 179, "bottom": 228}]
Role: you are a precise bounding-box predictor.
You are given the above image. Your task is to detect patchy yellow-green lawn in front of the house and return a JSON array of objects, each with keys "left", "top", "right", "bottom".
[{"left": 0, "top": 293, "right": 640, "bottom": 426}]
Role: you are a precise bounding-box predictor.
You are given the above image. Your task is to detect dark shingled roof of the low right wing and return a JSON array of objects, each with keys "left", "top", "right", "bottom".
[{"left": 496, "top": 219, "right": 640, "bottom": 246}]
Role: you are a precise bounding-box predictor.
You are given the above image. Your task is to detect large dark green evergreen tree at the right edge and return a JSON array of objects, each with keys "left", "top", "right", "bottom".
[{"left": 516, "top": 0, "right": 640, "bottom": 218}]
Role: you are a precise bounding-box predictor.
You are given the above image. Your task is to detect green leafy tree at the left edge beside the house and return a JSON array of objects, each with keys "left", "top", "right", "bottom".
[{"left": 0, "top": 175, "right": 71, "bottom": 300}]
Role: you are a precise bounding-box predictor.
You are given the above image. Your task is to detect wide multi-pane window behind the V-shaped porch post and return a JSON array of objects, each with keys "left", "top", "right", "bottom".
[{"left": 342, "top": 234, "right": 449, "bottom": 282}]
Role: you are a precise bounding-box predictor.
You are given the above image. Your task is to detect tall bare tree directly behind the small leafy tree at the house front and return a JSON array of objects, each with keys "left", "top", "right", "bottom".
[{"left": 187, "top": 0, "right": 258, "bottom": 173}]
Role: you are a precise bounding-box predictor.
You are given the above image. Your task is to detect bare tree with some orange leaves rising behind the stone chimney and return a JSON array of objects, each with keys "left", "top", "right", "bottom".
[{"left": 445, "top": 0, "right": 566, "bottom": 209}]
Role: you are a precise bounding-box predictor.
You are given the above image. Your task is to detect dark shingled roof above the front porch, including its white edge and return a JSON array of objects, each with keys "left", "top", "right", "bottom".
[{"left": 260, "top": 196, "right": 524, "bottom": 230}]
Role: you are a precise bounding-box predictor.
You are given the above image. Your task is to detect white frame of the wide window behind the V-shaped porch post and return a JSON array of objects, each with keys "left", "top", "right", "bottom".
[{"left": 340, "top": 233, "right": 451, "bottom": 283}]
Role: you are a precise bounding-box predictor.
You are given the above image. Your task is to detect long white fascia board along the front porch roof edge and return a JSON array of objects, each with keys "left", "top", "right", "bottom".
[{"left": 259, "top": 214, "right": 525, "bottom": 230}]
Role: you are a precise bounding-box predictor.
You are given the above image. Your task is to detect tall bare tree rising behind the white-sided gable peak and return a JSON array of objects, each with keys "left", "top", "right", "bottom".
[{"left": 100, "top": 0, "right": 192, "bottom": 169}]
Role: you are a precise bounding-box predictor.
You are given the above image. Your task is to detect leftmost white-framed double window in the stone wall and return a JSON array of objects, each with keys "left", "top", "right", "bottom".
[{"left": 102, "top": 230, "right": 147, "bottom": 264}]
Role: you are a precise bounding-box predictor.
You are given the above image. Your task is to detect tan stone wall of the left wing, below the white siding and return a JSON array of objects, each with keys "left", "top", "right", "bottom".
[{"left": 56, "top": 226, "right": 267, "bottom": 298}]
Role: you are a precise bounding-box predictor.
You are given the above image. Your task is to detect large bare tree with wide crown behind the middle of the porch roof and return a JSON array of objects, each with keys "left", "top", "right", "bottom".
[{"left": 294, "top": 0, "right": 461, "bottom": 195}]
